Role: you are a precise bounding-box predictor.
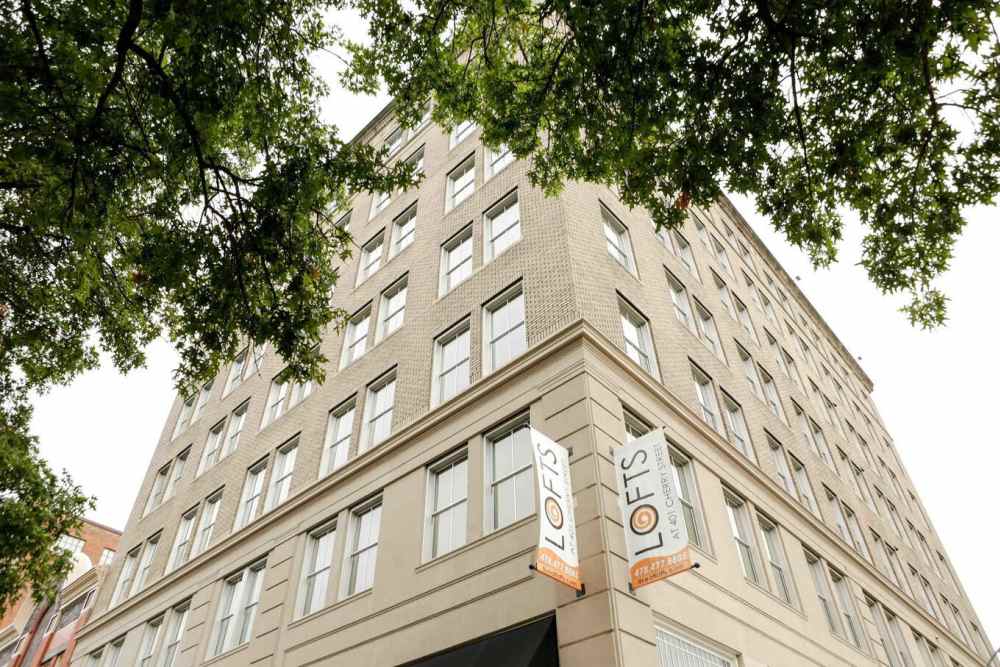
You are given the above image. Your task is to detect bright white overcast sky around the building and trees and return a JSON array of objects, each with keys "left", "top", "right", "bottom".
[{"left": 32, "top": 20, "right": 1000, "bottom": 642}]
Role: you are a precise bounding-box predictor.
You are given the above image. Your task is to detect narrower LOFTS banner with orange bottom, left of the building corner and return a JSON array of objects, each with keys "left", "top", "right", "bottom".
[{"left": 531, "top": 429, "right": 583, "bottom": 591}]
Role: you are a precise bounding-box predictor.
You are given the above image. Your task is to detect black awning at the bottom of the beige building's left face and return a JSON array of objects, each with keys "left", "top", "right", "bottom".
[{"left": 406, "top": 616, "right": 559, "bottom": 667}]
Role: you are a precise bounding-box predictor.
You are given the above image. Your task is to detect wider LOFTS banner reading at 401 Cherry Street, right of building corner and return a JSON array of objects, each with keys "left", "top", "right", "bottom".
[{"left": 614, "top": 429, "right": 692, "bottom": 589}]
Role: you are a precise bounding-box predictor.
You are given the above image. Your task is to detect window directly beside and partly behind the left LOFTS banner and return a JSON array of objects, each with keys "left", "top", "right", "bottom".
[{"left": 486, "top": 418, "right": 535, "bottom": 530}]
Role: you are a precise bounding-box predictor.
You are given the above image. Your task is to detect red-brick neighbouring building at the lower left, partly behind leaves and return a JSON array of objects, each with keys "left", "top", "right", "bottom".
[{"left": 0, "top": 519, "right": 121, "bottom": 667}]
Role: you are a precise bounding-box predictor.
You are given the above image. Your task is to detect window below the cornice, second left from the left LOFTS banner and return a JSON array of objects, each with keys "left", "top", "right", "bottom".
[{"left": 424, "top": 452, "right": 469, "bottom": 559}]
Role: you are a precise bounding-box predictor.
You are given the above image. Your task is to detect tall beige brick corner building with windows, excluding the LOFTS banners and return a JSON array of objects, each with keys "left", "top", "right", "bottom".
[{"left": 74, "top": 104, "right": 988, "bottom": 667}]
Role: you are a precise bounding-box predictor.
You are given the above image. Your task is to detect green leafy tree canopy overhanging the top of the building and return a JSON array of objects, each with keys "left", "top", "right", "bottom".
[{"left": 0, "top": 0, "right": 1000, "bottom": 604}]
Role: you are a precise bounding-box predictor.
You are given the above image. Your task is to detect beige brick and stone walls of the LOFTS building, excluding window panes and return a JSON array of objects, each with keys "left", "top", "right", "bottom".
[{"left": 74, "top": 105, "right": 985, "bottom": 667}]
